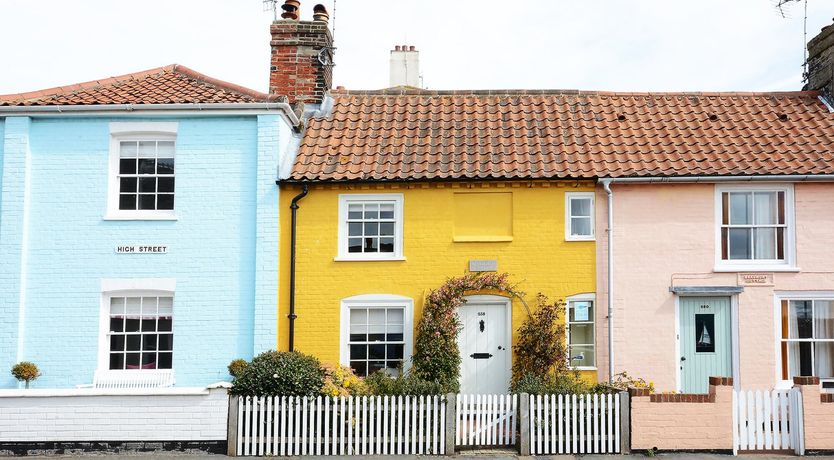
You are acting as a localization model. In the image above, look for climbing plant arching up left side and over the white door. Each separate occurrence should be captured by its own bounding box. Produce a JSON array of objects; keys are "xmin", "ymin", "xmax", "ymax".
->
[{"xmin": 412, "ymin": 273, "xmax": 524, "ymax": 392}]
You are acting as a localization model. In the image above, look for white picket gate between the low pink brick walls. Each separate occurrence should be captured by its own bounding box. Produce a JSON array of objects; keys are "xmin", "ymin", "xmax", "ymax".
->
[{"xmin": 733, "ymin": 389, "xmax": 805, "ymax": 455}]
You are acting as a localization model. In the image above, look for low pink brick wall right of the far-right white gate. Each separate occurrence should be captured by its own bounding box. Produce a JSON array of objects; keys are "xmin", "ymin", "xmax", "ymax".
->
[{"xmin": 794, "ymin": 377, "xmax": 834, "ymax": 451}]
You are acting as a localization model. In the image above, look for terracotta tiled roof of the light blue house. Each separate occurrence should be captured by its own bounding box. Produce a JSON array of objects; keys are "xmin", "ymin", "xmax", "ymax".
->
[{"xmin": 0, "ymin": 64, "xmax": 277, "ymax": 106}]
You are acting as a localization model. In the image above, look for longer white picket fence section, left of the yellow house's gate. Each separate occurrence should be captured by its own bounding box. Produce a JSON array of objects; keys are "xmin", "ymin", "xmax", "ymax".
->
[{"xmin": 235, "ymin": 396, "xmax": 446, "ymax": 456}]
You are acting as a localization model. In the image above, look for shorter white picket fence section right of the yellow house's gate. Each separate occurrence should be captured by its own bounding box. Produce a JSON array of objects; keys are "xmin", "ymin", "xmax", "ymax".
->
[{"xmin": 530, "ymin": 394, "xmax": 620, "ymax": 455}]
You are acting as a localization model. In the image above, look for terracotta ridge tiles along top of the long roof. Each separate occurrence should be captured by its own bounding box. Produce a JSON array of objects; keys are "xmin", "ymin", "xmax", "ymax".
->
[{"xmin": 330, "ymin": 86, "xmax": 820, "ymax": 97}]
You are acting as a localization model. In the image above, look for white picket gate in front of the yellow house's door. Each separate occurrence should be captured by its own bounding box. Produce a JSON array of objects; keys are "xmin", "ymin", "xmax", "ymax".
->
[{"xmin": 455, "ymin": 394, "xmax": 518, "ymax": 446}]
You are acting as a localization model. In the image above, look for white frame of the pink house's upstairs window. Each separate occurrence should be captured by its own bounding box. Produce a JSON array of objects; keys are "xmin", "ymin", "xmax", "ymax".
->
[{"xmin": 713, "ymin": 183, "xmax": 799, "ymax": 273}]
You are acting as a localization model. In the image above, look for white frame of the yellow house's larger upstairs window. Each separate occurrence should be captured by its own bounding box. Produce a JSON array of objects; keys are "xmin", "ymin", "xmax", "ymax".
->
[{"xmin": 334, "ymin": 193, "xmax": 405, "ymax": 262}]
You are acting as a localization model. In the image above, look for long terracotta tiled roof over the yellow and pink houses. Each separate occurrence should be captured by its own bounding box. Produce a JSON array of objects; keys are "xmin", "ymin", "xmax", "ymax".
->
[{"xmin": 290, "ymin": 89, "xmax": 834, "ymax": 181}]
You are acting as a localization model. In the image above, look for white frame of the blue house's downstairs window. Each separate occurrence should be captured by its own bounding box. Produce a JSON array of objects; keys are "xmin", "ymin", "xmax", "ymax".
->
[{"xmin": 96, "ymin": 278, "xmax": 177, "ymax": 377}]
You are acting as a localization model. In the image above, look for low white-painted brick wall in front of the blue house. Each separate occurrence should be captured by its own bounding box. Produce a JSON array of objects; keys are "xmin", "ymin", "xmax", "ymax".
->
[{"xmin": 0, "ymin": 388, "xmax": 229, "ymax": 442}]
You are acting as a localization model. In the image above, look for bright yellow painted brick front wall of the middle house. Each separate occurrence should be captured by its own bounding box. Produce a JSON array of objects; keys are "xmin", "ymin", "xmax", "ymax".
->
[{"xmin": 277, "ymin": 182, "xmax": 599, "ymax": 381}]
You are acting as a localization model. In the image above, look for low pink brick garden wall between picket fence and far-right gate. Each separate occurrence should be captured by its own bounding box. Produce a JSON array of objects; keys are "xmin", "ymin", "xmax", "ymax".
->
[{"xmin": 631, "ymin": 377, "xmax": 733, "ymax": 450}]
